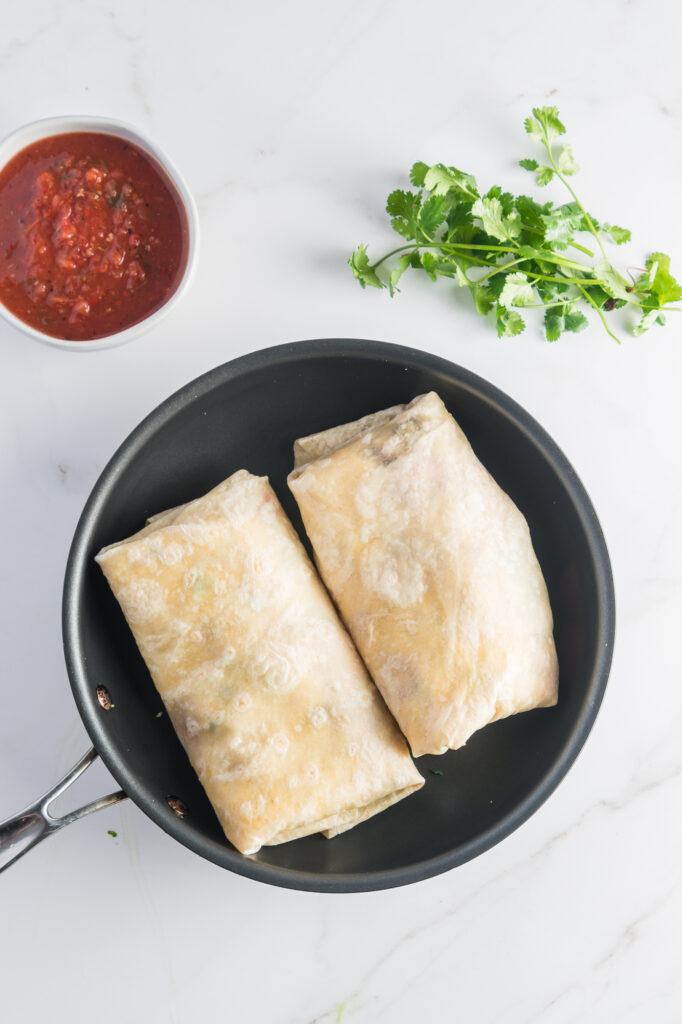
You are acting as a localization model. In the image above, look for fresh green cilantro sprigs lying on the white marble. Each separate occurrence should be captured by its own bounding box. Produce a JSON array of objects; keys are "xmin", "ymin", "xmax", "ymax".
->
[{"xmin": 348, "ymin": 106, "xmax": 682, "ymax": 341}]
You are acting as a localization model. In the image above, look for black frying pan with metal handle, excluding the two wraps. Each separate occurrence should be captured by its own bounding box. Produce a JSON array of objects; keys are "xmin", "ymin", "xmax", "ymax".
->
[{"xmin": 0, "ymin": 340, "xmax": 614, "ymax": 892}]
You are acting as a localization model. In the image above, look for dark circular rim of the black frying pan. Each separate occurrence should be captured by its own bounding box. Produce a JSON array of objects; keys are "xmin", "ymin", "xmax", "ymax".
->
[{"xmin": 62, "ymin": 338, "xmax": 615, "ymax": 893}]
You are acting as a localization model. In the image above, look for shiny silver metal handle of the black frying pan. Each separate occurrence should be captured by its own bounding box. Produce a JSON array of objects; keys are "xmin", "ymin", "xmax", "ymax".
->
[{"xmin": 0, "ymin": 748, "xmax": 126, "ymax": 871}]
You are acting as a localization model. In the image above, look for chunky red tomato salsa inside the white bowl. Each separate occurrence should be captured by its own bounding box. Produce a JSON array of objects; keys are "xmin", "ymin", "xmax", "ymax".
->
[{"xmin": 0, "ymin": 132, "xmax": 187, "ymax": 341}]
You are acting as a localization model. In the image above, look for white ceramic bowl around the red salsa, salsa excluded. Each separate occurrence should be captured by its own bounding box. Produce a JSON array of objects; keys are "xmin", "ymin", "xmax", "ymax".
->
[{"xmin": 0, "ymin": 115, "xmax": 199, "ymax": 352}]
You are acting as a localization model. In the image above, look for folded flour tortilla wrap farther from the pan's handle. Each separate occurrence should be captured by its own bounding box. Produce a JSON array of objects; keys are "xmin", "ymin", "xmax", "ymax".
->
[{"xmin": 289, "ymin": 392, "xmax": 558, "ymax": 757}]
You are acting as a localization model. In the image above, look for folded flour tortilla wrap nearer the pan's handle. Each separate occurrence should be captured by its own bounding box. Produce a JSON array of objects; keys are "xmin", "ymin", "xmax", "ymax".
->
[{"xmin": 96, "ymin": 470, "xmax": 424, "ymax": 854}]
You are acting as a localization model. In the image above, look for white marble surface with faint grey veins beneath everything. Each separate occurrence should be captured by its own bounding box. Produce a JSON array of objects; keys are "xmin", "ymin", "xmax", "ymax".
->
[{"xmin": 0, "ymin": 0, "xmax": 682, "ymax": 1024}]
